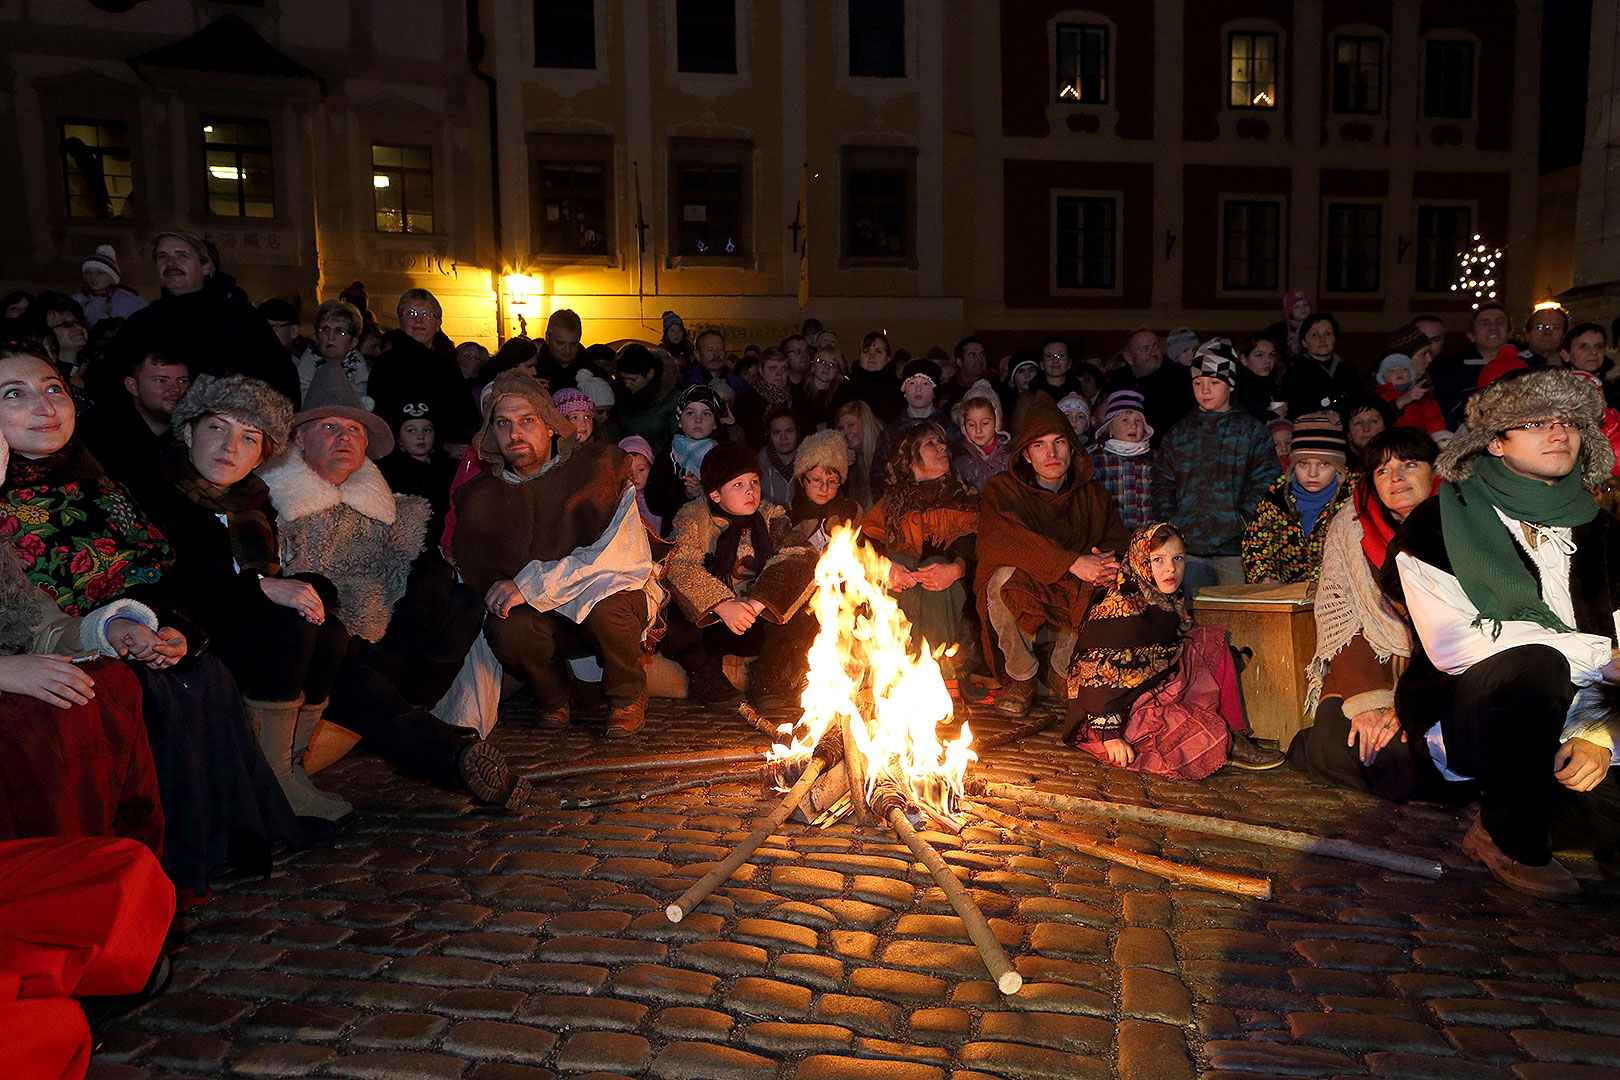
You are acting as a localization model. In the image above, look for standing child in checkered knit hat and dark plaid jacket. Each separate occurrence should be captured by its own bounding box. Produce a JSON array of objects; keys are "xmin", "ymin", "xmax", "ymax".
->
[{"xmin": 1152, "ymin": 337, "xmax": 1277, "ymax": 599}]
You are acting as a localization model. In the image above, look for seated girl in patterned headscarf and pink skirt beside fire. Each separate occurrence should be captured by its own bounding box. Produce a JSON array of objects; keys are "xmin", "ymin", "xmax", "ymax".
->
[{"xmin": 1064, "ymin": 523, "xmax": 1283, "ymax": 780}]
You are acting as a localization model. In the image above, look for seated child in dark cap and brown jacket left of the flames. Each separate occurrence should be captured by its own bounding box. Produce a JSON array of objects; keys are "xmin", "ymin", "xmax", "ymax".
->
[{"xmin": 663, "ymin": 442, "xmax": 816, "ymax": 706}]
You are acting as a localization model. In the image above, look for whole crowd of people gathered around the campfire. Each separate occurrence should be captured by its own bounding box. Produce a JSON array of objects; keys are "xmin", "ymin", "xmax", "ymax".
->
[{"xmin": 0, "ymin": 232, "xmax": 1620, "ymax": 904}]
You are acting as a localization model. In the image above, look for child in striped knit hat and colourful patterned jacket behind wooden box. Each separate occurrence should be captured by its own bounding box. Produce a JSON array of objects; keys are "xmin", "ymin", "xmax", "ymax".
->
[{"xmin": 1243, "ymin": 413, "xmax": 1356, "ymax": 583}]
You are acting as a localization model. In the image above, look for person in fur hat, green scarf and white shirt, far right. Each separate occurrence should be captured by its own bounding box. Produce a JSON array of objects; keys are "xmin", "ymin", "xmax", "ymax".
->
[{"xmin": 1383, "ymin": 369, "xmax": 1620, "ymax": 899}]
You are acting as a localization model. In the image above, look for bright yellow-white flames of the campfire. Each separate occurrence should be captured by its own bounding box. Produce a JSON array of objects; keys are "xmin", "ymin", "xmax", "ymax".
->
[{"xmin": 771, "ymin": 526, "xmax": 978, "ymax": 814}]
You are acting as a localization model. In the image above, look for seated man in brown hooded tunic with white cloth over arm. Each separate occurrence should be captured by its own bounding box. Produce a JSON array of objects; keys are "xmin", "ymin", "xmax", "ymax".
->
[{"xmin": 452, "ymin": 371, "xmax": 663, "ymax": 738}]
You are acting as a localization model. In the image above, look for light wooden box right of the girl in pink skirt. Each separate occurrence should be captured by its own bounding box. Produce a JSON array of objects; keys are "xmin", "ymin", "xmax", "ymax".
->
[{"xmin": 1192, "ymin": 585, "xmax": 1315, "ymax": 750}]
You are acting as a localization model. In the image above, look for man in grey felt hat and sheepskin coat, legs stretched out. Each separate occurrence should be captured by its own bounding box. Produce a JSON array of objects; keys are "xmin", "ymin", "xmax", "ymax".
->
[{"xmin": 259, "ymin": 364, "xmax": 528, "ymax": 810}]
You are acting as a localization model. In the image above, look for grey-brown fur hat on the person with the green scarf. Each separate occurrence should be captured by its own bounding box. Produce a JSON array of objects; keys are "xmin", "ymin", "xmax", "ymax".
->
[{"xmin": 1434, "ymin": 368, "xmax": 1615, "ymax": 487}]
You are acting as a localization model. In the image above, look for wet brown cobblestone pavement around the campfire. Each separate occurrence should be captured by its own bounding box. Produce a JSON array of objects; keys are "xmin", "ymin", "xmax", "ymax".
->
[{"xmin": 91, "ymin": 703, "xmax": 1620, "ymax": 1080}]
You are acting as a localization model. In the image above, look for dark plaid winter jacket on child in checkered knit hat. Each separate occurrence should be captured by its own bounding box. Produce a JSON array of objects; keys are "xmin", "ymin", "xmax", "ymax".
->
[{"xmin": 1153, "ymin": 406, "xmax": 1277, "ymax": 555}]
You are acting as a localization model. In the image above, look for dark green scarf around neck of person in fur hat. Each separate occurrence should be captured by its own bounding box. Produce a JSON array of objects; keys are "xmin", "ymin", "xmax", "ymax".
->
[{"xmin": 1439, "ymin": 455, "xmax": 1597, "ymax": 638}]
